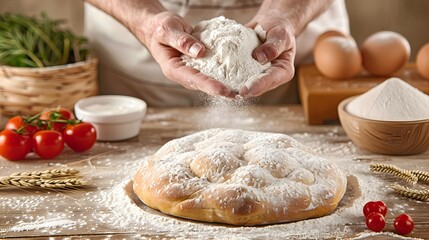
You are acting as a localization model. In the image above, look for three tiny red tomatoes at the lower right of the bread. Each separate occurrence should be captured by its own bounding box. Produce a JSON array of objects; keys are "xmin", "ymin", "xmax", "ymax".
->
[{"xmin": 363, "ymin": 201, "xmax": 414, "ymax": 235}]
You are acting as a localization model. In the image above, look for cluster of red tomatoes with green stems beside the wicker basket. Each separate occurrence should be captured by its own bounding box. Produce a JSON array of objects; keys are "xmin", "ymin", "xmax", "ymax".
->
[{"xmin": 0, "ymin": 107, "xmax": 97, "ymax": 160}]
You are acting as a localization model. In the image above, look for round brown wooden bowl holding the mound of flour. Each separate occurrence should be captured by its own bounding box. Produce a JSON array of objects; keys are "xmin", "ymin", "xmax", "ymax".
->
[{"xmin": 338, "ymin": 97, "xmax": 429, "ymax": 155}]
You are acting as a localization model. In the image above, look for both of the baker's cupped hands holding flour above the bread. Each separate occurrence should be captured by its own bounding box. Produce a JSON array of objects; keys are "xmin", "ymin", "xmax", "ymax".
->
[{"xmin": 137, "ymin": 12, "xmax": 296, "ymax": 98}]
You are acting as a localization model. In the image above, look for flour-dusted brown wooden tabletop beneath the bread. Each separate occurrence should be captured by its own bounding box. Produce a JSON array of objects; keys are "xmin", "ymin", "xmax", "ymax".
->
[{"xmin": 0, "ymin": 105, "xmax": 429, "ymax": 239}]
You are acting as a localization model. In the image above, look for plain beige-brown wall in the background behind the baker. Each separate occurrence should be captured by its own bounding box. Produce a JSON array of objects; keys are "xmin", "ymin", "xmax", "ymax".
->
[{"xmin": 0, "ymin": 0, "xmax": 429, "ymax": 60}]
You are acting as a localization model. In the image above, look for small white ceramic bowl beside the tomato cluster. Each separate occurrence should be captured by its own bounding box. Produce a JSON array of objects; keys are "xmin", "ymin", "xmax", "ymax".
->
[{"xmin": 74, "ymin": 95, "xmax": 147, "ymax": 141}]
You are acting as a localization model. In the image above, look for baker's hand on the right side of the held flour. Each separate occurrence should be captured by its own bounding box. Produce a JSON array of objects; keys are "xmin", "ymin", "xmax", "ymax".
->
[{"xmin": 239, "ymin": 12, "xmax": 296, "ymax": 97}]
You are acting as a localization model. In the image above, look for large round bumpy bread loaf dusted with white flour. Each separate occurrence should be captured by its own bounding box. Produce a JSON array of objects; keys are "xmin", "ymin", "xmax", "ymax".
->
[{"xmin": 133, "ymin": 129, "xmax": 346, "ymax": 226}]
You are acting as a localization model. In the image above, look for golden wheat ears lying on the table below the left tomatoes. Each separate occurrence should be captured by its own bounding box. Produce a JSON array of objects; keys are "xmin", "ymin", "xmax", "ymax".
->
[{"xmin": 0, "ymin": 168, "xmax": 89, "ymax": 189}]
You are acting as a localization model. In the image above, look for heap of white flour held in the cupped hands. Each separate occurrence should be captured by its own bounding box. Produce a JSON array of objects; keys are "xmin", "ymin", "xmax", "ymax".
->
[{"xmin": 182, "ymin": 16, "xmax": 270, "ymax": 90}]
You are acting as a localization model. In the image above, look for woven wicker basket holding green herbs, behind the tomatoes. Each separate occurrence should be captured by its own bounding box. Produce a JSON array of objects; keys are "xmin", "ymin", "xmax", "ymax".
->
[{"xmin": 0, "ymin": 58, "xmax": 98, "ymax": 115}]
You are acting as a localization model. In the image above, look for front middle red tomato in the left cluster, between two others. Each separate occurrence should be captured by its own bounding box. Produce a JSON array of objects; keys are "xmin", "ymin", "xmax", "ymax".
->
[{"xmin": 33, "ymin": 130, "xmax": 64, "ymax": 159}]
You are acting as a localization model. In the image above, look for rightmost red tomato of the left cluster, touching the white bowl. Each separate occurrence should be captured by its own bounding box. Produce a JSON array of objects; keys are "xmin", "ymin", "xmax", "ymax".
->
[{"xmin": 64, "ymin": 122, "xmax": 97, "ymax": 152}]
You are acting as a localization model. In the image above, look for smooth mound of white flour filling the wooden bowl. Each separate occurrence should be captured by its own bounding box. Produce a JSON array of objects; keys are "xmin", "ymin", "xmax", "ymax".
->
[{"xmin": 346, "ymin": 78, "xmax": 429, "ymax": 121}]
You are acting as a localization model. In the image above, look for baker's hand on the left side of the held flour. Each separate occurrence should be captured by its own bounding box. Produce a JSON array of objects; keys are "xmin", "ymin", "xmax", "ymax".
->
[{"xmin": 137, "ymin": 12, "xmax": 236, "ymax": 98}]
